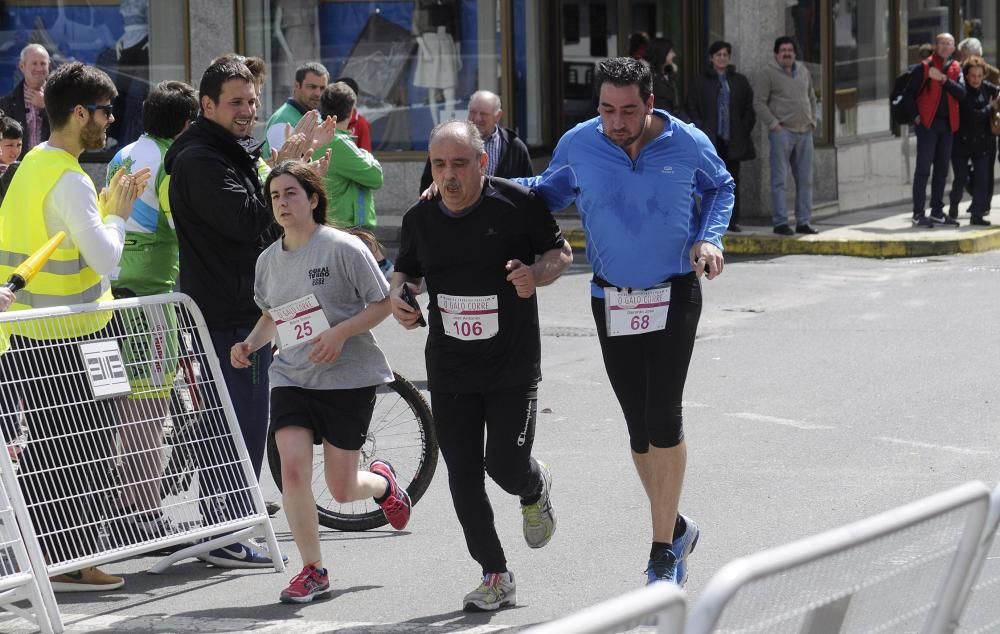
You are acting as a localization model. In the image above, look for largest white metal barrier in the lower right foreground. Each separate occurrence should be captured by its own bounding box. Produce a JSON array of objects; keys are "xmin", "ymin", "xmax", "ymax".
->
[{"xmin": 685, "ymin": 482, "xmax": 989, "ymax": 634}]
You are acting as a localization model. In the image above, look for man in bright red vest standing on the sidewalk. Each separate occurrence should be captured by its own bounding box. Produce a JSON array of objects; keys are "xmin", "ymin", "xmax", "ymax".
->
[{"xmin": 903, "ymin": 33, "xmax": 965, "ymax": 229}]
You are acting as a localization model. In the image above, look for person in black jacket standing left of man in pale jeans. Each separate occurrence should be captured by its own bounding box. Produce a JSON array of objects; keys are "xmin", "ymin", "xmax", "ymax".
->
[{"xmin": 687, "ymin": 41, "xmax": 757, "ymax": 232}]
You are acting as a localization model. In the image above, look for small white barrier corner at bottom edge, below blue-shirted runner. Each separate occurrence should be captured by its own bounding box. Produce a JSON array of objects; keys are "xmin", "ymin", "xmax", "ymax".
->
[{"xmin": 524, "ymin": 583, "xmax": 686, "ymax": 634}]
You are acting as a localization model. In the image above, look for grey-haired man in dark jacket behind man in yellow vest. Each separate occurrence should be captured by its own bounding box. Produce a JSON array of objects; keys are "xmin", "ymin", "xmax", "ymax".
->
[{"xmin": 0, "ymin": 44, "xmax": 49, "ymax": 160}]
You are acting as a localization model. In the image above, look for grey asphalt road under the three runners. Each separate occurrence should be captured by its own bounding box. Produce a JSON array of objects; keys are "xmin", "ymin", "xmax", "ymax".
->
[{"xmin": 0, "ymin": 252, "xmax": 1000, "ymax": 634}]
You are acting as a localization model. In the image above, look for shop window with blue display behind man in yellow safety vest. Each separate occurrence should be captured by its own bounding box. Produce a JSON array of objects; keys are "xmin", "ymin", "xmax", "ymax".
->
[{"xmin": 0, "ymin": 0, "xmax": 187, "ymax": 160}]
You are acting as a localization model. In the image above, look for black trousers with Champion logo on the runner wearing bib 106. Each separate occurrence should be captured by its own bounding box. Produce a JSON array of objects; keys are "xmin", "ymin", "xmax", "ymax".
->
[{"xmin": 431, "ymin": 382, "xmax": 542, "ymax": 575}]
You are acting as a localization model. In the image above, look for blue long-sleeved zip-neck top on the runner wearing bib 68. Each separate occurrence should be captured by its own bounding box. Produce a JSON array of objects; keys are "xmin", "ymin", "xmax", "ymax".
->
[{"xmin": 512, "ymin": 110, "xmax": 735, "ymax": 297}]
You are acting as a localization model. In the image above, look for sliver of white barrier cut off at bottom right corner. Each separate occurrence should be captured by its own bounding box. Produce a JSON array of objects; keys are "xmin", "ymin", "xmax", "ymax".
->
[{"xmin": 954, "ymin": 486, "xmax": 1000, "ymax": 634}]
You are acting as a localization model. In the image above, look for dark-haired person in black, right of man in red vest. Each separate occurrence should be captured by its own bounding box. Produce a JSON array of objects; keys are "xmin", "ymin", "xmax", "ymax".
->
[{"xmin": 948, "ymin": 55, "xmax": 1000, "ymax": 226}]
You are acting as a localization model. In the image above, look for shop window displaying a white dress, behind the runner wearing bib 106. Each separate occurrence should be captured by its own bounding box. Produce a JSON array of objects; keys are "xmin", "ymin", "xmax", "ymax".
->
[{"xmin": 244, "ymin": 0, "xmax": 501, "ymax": 152}]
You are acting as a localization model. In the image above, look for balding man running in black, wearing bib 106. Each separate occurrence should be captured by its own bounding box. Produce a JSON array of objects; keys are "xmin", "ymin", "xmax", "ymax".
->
[{"xmin": 389, "ymin": 121, "xmax": 573, "ymax": 611}]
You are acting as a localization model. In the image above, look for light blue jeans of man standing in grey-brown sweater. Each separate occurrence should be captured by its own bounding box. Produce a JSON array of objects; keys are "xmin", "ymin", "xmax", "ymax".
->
[{"xmin": 767, "ymin": 128, "xmax": 813, "ymax": 227}]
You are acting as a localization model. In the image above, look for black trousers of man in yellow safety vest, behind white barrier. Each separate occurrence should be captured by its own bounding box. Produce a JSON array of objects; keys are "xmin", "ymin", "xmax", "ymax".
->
[{"xmin": 0, "ymin": 327, "xmax": 118, "ymax": 564}]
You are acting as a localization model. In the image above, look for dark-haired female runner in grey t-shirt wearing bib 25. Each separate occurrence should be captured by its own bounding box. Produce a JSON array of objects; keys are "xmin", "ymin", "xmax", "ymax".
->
[{"xmin": 230, "ymin": 161, "xmax": 411, "ymax": 603}]
